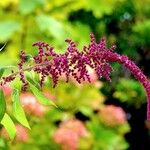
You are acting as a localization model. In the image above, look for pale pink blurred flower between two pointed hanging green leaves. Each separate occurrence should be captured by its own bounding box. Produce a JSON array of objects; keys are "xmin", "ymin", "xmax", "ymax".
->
[{"xmin": 20, "ymin": 93, "xmax": 46, "ymax": 117}]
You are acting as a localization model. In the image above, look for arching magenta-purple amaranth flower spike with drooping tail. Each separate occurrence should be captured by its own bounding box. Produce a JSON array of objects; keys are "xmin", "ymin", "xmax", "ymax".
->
[{"xmin": 1, "ymin": 34, "xmax": 150, "ymax": 120}]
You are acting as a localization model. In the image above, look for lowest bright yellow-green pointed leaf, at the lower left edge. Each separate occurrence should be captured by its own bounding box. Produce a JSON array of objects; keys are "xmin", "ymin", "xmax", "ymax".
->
[{"xmin": 1, "ymin": 113, "xmax": 16, "ymax": 140}]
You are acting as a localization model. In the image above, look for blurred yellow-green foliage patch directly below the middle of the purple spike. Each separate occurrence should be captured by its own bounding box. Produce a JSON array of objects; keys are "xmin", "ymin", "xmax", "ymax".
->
[{"xmin": 51, "ymin": 81, "xmax": 104, "ymax": 113}]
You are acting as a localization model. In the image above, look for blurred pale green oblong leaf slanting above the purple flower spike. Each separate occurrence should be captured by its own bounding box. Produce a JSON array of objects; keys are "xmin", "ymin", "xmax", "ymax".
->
[{"xmin": 36, "ymin": 15, "xmax": 65, "ymax": 41}]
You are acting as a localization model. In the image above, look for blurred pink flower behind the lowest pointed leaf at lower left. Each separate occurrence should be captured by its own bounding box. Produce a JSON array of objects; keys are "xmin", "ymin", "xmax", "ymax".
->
[{"xmin": 1, "ymin": 124, "xmax": 29, "ymax": 142}]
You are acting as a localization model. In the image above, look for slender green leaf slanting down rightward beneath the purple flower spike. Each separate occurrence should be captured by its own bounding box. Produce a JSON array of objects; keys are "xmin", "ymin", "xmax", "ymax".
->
[{"xmin": 29, "ymin": 82, "xmax": 57, "ymax": 107}]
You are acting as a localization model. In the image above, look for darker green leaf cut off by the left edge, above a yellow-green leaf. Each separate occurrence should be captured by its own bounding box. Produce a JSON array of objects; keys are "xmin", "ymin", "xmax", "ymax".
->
[{"xmin": 0, "ymin": 89, "xmax": 6, "ymax": 121}]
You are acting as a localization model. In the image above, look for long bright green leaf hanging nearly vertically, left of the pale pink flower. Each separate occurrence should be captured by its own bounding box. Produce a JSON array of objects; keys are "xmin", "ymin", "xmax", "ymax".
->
[{"xmin": 12, "ymin": 89, "xmax": 30, "ymax": 129}]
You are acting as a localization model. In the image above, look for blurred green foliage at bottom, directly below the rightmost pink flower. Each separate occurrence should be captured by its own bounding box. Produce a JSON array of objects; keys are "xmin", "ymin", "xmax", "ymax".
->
[{"xmin": 87, "ymin": 118, "xmax": 129, "ymax": 150}]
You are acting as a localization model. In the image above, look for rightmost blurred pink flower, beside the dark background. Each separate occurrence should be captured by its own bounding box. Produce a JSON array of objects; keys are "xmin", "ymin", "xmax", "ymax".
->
[{"xmin": 99, "ymin": 105, "xmax": 126, "ymax": 127}]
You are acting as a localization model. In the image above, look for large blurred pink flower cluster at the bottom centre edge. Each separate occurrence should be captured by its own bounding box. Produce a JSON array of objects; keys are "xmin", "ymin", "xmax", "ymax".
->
[{"xmin": 54, "ymin": 119, "xmax": 88, "ymax": 150}]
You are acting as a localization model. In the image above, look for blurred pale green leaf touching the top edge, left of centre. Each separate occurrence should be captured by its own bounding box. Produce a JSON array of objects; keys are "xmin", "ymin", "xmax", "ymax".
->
[{"xmin": 19, "ymin": 0, "xmax": 45, "ymax": 15}]
